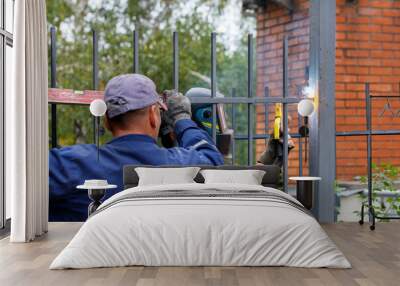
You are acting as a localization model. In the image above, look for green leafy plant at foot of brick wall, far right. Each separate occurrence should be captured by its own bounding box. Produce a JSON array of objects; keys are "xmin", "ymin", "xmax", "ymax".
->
[{"xmin": 357, "ymin": 163, "xmax": 400, "ymax": 219}]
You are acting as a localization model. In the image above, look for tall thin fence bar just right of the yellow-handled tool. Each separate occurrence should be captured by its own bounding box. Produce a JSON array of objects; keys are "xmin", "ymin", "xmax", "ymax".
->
[{"xmin": 282, "ymin": 35, "xmax": 289, "ymax": 193}]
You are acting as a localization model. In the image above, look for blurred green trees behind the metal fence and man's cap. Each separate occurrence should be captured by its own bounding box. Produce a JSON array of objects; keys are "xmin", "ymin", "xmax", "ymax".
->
[{"xmin": 47, "ymin": 0, "xmax": 255, "ymax": 164}]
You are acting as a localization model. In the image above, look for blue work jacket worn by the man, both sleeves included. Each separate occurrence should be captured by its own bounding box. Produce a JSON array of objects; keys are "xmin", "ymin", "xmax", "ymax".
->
[{"xmin": 49, "ymin": 119, "xmax": 223, "ymax": 221}]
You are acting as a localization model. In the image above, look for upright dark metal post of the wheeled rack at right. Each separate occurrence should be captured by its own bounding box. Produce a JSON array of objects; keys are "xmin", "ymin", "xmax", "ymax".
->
[{"xmin": 365, "ymin": 83, "xmax": 372, "ymax": 222}]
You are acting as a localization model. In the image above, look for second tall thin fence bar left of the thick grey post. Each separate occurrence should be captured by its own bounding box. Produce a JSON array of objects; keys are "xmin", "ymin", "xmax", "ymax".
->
[{"xmin": 247, "ymin": 34, "xmax": 254, "ymax": 166}]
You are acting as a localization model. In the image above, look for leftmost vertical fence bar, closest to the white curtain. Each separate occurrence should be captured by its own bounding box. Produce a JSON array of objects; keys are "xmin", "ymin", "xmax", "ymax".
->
[{"xmin": 50, "ymin": 27, "xmax": 58, "ymax": 148}]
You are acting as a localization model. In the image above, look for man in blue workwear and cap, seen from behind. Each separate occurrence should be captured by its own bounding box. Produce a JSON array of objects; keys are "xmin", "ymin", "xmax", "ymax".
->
[{"xmin": 49, "ymin": 74, "xmax": 223, "ymax": 221}]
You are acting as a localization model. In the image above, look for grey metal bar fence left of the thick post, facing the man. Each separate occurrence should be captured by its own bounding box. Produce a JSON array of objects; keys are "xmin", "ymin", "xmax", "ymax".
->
[{"xmin": 49, "ymin": 27, "xmax": 303, "ymax": 192}]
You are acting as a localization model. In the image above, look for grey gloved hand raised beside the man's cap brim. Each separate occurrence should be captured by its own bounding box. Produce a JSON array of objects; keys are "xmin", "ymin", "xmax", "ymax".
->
[{"xmin": 163, "ymin": 90, "xmax": 192, "ymax": 126}]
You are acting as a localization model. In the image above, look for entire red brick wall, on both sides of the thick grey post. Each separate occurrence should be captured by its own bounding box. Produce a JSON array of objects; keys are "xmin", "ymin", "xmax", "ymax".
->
[{"xmin": 256, "ymin": 0, "xmax": 400, "ymax": 180}]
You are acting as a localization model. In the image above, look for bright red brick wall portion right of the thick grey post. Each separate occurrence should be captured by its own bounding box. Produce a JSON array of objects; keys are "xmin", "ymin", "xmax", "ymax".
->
[{"xmin": 336, "ymin": 0, "xmax": 400, "ymax": 179}]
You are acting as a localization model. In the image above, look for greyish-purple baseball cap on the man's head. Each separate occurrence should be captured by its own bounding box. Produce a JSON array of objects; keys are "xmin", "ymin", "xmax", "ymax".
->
[{"xmin": 104, "ymin": 74, "xmax": 166, "ymax": 118}]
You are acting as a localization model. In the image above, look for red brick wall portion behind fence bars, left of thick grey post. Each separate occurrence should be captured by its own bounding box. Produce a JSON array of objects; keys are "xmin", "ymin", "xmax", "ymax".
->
[{"xmin": 256, "ymin": 0, "xmax": 309, "ymax": 175}]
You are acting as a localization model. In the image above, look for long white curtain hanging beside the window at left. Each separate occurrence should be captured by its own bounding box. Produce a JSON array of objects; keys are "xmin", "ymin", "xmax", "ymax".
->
[{"xmin": 5, "ymin": 0, "xmax": 48, "ymax": 242}]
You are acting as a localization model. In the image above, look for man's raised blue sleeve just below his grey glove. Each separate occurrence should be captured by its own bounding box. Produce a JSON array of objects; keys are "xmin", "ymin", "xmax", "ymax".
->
[{"xmin": 172, "ymin": 119, "xmax": 224, "ymax": 165}]
